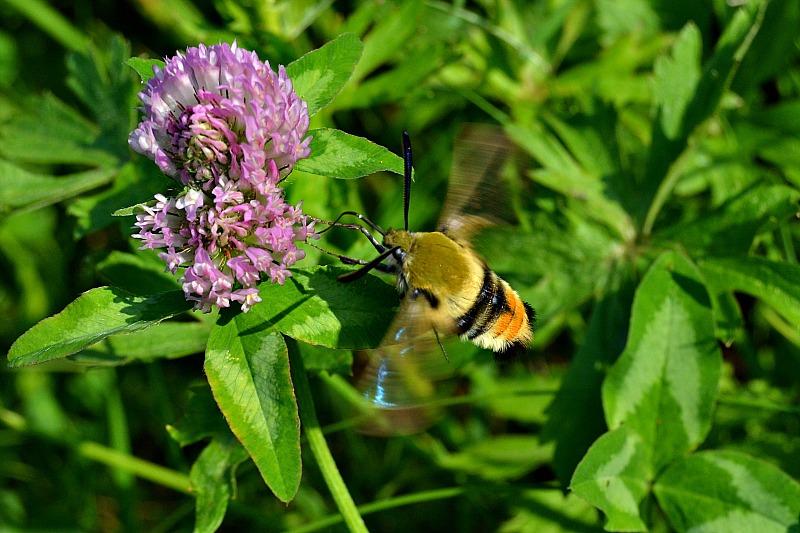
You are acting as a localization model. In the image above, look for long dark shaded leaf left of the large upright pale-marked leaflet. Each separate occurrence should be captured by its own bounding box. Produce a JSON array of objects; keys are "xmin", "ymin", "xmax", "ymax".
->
[{"xmin": 542, "ymin": 268, "xmax": 634, "ymax": 486}]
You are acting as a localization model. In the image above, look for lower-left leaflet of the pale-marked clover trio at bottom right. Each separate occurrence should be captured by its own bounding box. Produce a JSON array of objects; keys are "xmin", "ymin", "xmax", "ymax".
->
[{"xmin": 570, "ymin": 426, "xmax": 653, "ymax": 531}]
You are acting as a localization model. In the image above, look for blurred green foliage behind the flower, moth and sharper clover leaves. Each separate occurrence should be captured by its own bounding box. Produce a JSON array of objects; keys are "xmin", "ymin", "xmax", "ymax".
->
[{"xmin": 0, "ymin": 0, "xmax": 800, "ymax": 532}]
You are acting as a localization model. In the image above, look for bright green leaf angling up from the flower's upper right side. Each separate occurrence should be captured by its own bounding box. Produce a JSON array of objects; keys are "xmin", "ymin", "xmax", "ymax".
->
[{"xmin": 286, "ymin": 33, "xmax": 364, "ymax": 116}]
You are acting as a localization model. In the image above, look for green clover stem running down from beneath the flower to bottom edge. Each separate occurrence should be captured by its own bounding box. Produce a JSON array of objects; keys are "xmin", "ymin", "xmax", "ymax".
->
[{"xmin": 286, "ymin": 338, "xmax": 368, "ymax": 533}]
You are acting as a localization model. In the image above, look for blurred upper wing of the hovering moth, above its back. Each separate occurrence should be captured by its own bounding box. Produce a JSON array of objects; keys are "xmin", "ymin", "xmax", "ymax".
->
[{"xmin": 437, "ymin": 124, "xmax": 516, "ymax": 240}]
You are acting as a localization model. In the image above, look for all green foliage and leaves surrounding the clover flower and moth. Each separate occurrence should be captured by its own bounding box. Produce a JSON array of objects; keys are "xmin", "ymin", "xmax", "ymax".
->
[{"xmin": 0, "ymin": 0, "xmax": 800, "ymax": 533}]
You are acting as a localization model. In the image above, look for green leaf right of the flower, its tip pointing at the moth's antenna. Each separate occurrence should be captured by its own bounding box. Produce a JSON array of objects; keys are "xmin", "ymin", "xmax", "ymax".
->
[{"xmin": 295, "ymin": 128, "xmax": 403, "ymax": 179}]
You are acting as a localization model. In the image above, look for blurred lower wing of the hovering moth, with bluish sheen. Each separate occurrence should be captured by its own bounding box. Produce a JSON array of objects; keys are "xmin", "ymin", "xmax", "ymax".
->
[{"xmin": 356, "ymin": 299, "xmax": 454, "ymax": 436}]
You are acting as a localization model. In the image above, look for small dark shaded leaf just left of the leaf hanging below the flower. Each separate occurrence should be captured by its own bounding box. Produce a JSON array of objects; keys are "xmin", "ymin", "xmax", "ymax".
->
[{"xmin": 167, "ymin": 385, "xmax": 233, "ymax": 447}]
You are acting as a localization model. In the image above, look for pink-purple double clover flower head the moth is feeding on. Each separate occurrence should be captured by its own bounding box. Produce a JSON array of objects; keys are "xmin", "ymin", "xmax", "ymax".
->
[{"xmin": 129, "ymin": 43, "xmax": 317, "ymax": 312}]
